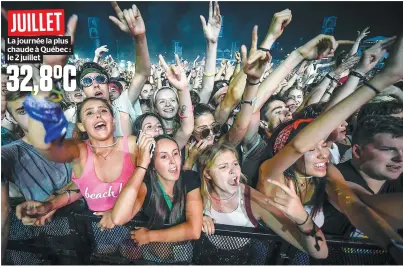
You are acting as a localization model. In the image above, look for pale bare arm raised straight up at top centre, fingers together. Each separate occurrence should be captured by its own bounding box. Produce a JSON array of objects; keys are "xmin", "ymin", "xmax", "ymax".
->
[{"xmin": 199, "ymin": 1, "xmax": 221, "ymax": 104}]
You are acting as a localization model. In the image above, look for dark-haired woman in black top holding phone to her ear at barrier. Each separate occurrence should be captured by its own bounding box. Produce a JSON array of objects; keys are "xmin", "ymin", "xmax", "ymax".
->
[{"xmin": 112, "ymin": 134, "xmax": 203, "ymax": 261}]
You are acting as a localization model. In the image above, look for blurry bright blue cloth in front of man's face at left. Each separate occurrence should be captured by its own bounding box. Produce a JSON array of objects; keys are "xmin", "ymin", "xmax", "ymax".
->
[{"xmin": 23, "ymin": 94, "xmax": 68, "ymax": 145}]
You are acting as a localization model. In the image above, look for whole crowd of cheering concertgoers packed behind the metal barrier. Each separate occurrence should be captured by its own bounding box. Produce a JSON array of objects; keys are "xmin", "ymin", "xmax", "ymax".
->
[{"xmin": 1, "ymin": 2, "xmax": 403, "ymax": 262}]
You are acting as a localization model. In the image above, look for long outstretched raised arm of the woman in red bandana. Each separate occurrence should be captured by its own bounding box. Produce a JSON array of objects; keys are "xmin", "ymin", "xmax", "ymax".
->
[{"xmin": 259, "ymin": 35, "xmax": 403, "ymax": 181}]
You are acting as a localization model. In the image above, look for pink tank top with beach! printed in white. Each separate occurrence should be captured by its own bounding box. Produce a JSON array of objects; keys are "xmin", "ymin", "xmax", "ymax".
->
[{"xmin": 72, "ymin": 136, "xmax": 134, "ymax": 212}]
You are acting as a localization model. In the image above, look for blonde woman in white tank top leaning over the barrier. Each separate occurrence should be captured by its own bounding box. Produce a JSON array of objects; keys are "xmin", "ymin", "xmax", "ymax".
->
[{"xmin": 198, "ymin": 144, "xmax": 328, "ymax": 258}]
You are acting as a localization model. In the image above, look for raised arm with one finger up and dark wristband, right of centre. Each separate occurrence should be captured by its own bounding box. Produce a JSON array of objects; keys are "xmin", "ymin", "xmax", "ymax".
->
[{"xmin": 221, "ymin": 26, "xmax": 271, "ymax": 146}]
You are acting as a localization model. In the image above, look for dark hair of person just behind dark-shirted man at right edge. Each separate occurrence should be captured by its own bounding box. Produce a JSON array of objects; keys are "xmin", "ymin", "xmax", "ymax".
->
[{"xmin": 357, "ymin": 101, "xmax": 403, "ymax": 121}]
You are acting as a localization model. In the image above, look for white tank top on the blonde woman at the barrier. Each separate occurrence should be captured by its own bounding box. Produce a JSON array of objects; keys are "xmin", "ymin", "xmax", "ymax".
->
[{"xmin": 205, "ymin": 184, "xmax": 255, "ymax": 227}]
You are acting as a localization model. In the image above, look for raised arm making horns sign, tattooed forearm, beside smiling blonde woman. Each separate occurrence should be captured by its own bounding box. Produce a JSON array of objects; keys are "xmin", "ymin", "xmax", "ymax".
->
[{"xmin": 159, "ymin": 55, "xmax": 194, "ymax": 150}]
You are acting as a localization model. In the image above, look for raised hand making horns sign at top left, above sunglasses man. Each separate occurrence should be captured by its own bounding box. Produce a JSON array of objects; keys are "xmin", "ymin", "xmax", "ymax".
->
[{"xmin": 109, "ymin": 1, "xmax": 146, "ymax": 38}]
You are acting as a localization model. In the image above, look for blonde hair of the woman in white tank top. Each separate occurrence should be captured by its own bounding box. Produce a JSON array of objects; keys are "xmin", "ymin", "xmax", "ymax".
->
[{"xmin": 197, "ymin": 143, "xmax": 248, "ymax": 211}]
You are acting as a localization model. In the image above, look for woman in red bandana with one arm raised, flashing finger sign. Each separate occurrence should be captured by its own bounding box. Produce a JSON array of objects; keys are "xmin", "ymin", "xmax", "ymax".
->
[{"xmin": 257, "ymin": 36, "xmax": 403, "ymax": 260}]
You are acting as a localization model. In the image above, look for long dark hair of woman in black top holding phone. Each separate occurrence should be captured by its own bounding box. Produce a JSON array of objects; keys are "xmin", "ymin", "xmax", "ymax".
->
[{"xmin": 146, "ymin": 135, "xmax": 186, "ymax": 229}]
